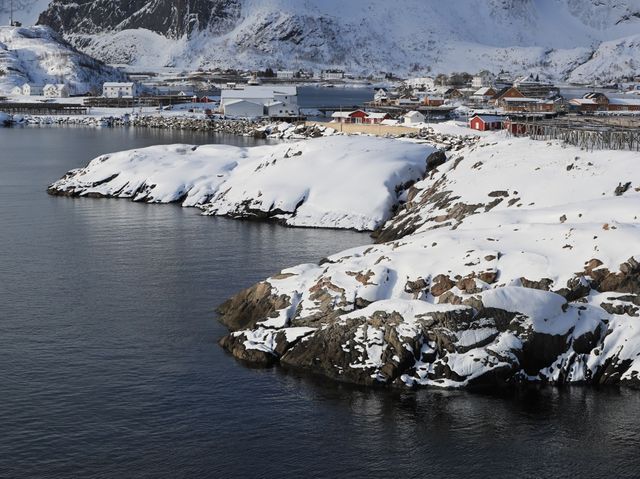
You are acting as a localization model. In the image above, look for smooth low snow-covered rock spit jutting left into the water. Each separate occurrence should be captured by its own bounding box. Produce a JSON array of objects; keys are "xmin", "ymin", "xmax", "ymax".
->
[{"xmin": 49, "ymin": 136, "xmax": 435, "ymax": 230}]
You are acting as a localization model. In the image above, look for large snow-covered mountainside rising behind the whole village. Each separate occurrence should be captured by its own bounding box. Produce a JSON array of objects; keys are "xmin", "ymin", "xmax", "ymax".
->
[{"xmin": 33, "ymin": 0, "xmax": 640, "ymax": 79}]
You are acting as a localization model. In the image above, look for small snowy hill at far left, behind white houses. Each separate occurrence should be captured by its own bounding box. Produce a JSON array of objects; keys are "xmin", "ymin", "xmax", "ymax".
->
[{"xmin": 0, "ymin": 27, "xmax": 122, "ymax": 94}]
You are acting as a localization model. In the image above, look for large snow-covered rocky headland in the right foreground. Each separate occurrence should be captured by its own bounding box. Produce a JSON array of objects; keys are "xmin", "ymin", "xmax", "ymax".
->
[{"xmin": 219, "ymin": 135, "xmax": 640, "ymax": 387}]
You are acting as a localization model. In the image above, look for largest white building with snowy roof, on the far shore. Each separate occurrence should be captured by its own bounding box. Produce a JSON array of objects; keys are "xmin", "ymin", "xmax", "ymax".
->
[{"xmin": 220, "ymin": 86, "xmax": 300, "ymax": 118}]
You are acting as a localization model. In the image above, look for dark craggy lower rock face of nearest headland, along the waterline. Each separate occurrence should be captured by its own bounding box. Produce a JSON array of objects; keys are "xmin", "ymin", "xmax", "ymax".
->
[{"xmin": 219, "ymin": 258, "xmax": 640, "ymax": 388}]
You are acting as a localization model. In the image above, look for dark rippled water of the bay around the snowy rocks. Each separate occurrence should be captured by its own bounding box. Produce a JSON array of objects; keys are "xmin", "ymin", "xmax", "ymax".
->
[{"xmin": 0, "ymin": 128, "xmax": 640, "ymax": 478}]
